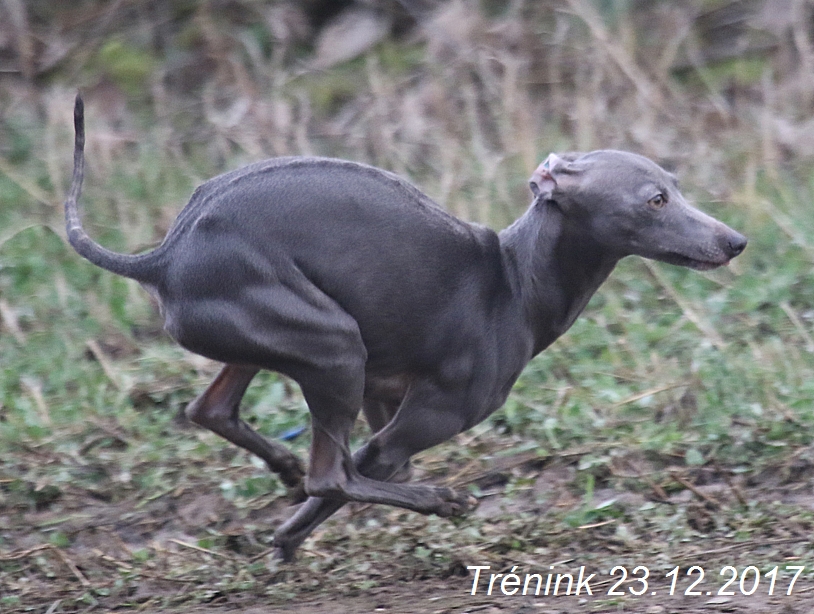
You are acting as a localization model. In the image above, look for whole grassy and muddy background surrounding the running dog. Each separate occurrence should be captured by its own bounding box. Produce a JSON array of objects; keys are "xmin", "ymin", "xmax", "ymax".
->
[{"xmin": 0, "ymin": 0, "xmax": 814, "ymax": 614}]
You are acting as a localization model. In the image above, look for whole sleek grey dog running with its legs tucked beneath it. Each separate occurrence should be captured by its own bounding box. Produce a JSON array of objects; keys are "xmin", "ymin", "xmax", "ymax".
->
[{"xmin": 65, "ymin": 96, "xmax": 746, "ymax": 560}]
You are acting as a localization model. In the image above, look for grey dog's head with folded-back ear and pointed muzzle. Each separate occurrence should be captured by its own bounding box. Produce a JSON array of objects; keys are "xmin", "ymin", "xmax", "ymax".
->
[{"xmin": 530, "ymin": 150, "xmax": 746, "ymax": 270}]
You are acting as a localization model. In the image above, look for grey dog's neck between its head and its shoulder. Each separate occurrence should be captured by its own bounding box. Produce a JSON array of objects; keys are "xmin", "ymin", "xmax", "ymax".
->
[{"xmin": 500, "ymin": 202, "xmax": 620, "ymax": 355}]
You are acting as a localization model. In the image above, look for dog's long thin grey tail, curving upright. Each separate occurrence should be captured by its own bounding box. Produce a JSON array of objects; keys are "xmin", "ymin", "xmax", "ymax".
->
[{"xmin": 65, "ymin": 94, "xmax": 158, "ymax": 283}]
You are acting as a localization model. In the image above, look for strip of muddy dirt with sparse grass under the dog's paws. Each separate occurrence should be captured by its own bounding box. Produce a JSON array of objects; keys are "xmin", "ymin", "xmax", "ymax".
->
[{"xmin": 6, "ymin": 450, "xmax": 814, "ymax": 614}]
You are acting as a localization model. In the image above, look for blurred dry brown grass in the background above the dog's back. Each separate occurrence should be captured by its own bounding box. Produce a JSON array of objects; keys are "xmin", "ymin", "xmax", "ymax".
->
[{"xmin": 0, "ymin": 0, "xmax": 814, "ymax": 233}]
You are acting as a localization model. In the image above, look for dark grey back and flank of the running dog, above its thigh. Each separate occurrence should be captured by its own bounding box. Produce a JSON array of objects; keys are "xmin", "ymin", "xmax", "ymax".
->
[{"xmin": 162, "ymin": 158, "xmax": 509, "ymax": 372}]
